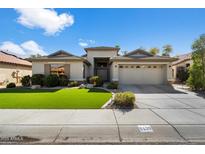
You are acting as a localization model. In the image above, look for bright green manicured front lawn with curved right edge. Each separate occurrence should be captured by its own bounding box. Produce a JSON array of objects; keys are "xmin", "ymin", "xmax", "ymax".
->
[{"xmin": 0, "ymin": 88, "xmax": 112, "ymax": 109}]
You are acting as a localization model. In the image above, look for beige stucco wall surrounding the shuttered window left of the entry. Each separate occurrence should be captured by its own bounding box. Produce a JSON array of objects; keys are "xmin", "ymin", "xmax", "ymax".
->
[{"xmin": 32, "ymin": 61, "xmax": 84, "ymax": 81}]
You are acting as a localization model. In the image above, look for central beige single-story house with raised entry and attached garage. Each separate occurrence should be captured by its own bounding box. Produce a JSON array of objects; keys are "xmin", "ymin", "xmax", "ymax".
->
[{"xmin": 31, "ymin": 47, "xmax": 177, "ymax": 84}]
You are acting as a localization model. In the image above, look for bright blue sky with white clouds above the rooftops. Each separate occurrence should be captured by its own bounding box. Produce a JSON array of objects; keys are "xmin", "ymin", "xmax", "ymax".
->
[{"xmin": 0, "ymin": 9, "xmax": 205, "ymax": 56}]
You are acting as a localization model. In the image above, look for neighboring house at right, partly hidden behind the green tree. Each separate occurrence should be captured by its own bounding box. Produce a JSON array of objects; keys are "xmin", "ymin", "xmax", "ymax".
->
[{"xmin": 172, "ymin": 53, "xmax": 193, "ymax": 81}]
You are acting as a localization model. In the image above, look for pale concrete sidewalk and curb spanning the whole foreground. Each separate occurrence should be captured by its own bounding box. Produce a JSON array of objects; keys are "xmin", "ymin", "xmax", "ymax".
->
[{"xmin": 0, "ymin": 108, "xmax": 205, "ymax": 144}]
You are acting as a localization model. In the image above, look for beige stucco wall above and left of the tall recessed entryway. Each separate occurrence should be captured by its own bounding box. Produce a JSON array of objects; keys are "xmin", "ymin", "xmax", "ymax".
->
[{"xmin": 87, "ymin": 50, "xmax": 117, "ymax": 76}]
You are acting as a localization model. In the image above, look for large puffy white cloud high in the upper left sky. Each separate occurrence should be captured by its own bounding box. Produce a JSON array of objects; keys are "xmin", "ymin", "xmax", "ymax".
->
[{"xmin": 16, "ymin": 8, "xmax": 74, "ymax": 35}]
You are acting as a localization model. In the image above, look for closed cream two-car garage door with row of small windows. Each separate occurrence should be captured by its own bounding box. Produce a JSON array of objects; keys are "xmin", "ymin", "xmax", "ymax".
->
[{"xmin": 119, "ymin": 65, "xmax": 165, "ymax": 84}]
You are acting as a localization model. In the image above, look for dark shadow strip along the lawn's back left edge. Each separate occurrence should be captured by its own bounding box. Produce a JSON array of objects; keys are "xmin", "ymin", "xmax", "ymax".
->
[{"xmin": 0, "ymin": 88, "xmax": 61, "ymax": 94}]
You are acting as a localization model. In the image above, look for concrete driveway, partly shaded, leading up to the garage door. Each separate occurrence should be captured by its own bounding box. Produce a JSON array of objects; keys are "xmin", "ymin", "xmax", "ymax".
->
[{"xmin": 120, "ymin": 85, "xmax": 205, "ymax": 109}]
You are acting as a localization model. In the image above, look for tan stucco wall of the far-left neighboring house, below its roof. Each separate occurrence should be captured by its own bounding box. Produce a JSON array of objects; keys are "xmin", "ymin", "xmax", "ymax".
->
[{"xmin": 0, "ymin": 63, "xmax": 32, "ymax": 83}]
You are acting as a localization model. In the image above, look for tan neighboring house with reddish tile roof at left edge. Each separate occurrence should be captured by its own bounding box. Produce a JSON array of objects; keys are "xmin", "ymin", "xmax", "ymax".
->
[{"xmin": 0, "ymin": 51, "xmax": 32, "ymax": 85}]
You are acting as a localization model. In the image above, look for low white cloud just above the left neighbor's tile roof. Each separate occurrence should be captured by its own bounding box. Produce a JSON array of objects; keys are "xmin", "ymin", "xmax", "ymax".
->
[{"xmin": 0, "ymin": 40, "xmax": 47, "ymax": 58}]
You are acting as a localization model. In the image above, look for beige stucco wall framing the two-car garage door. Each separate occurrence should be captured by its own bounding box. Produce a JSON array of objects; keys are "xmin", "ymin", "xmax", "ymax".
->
[{"xmin": 111, "ymin": 62, "xmax": 173, "ymax": 83}]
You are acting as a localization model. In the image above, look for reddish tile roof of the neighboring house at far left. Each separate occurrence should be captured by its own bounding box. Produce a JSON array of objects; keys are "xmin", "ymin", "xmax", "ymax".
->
[{"xmin": 0, "ymin": 51, "xmax": 31, "ymax": 66}]
